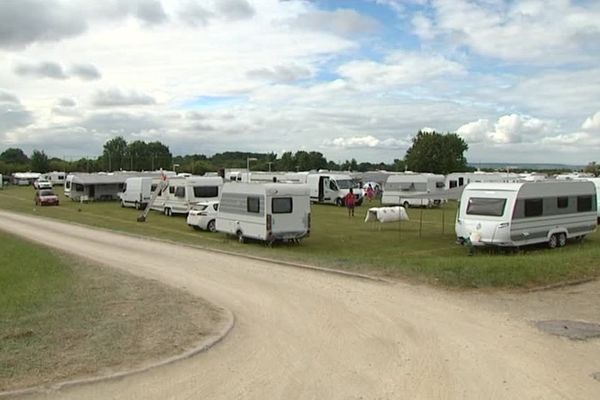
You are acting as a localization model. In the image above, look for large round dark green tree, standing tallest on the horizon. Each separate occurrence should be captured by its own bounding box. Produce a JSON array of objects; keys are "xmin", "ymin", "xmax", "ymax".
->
[{"xmin": 404, "ymin": 131, "xmax": 469, "ymax": 175}]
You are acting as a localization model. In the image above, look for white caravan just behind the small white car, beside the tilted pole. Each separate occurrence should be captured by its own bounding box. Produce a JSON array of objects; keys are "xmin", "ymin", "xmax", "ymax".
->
[{"xmin": 151, "ymin": 176, "xmax": 223, "ymax": 215}]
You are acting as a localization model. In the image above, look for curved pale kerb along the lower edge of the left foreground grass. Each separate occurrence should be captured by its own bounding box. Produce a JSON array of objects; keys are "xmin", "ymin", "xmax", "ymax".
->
[{"xmin": 0, "ymin": 309, "xmax": 235, "ymax": 399}]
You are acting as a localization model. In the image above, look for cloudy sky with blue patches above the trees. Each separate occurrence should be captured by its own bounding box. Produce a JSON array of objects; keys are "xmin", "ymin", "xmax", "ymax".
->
[{"xmin": 0, "ymin": 0, "xmax": 600, "ymax": 164}]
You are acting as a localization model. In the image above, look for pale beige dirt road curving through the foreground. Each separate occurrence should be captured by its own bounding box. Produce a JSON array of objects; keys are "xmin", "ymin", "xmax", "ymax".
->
[{"xmin": 0, "ymin": 212, "xmax": 600, "ymax": 400}]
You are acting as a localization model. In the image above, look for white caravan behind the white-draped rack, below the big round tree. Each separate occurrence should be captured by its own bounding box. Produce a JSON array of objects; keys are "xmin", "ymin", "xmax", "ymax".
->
[{"xmin": 381, "ymin": 173, "xmax": 446, "ymax": 208}]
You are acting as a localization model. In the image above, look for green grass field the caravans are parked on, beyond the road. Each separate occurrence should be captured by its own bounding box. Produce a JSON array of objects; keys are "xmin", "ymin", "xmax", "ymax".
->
[{"xmin": 0, "ymin": 187, "xmax": 600, "ymax": 287}]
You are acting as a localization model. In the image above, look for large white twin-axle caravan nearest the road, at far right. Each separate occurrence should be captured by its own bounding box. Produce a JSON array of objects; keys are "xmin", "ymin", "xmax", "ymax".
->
[{"xmin": 455, "ymin": 181, "xmax": 597, "ymax": 248}]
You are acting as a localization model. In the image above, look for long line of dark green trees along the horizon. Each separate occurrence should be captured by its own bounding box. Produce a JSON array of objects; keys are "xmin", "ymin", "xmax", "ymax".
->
[{"xmin": 5, "ymin": 131, "xmax": 600, "ymax": 175}]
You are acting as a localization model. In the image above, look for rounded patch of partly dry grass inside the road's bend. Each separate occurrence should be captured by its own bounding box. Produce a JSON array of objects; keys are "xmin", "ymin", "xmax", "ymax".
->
[{"xmin": 0, "ymin": 231, "xmax": 220, "ymax": 392}]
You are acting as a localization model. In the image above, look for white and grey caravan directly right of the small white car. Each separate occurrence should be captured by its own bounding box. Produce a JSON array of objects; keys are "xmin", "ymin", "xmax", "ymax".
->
[{"xmin": 216, "ymin": 182, "xmax": 310, "ymax": 243}]
